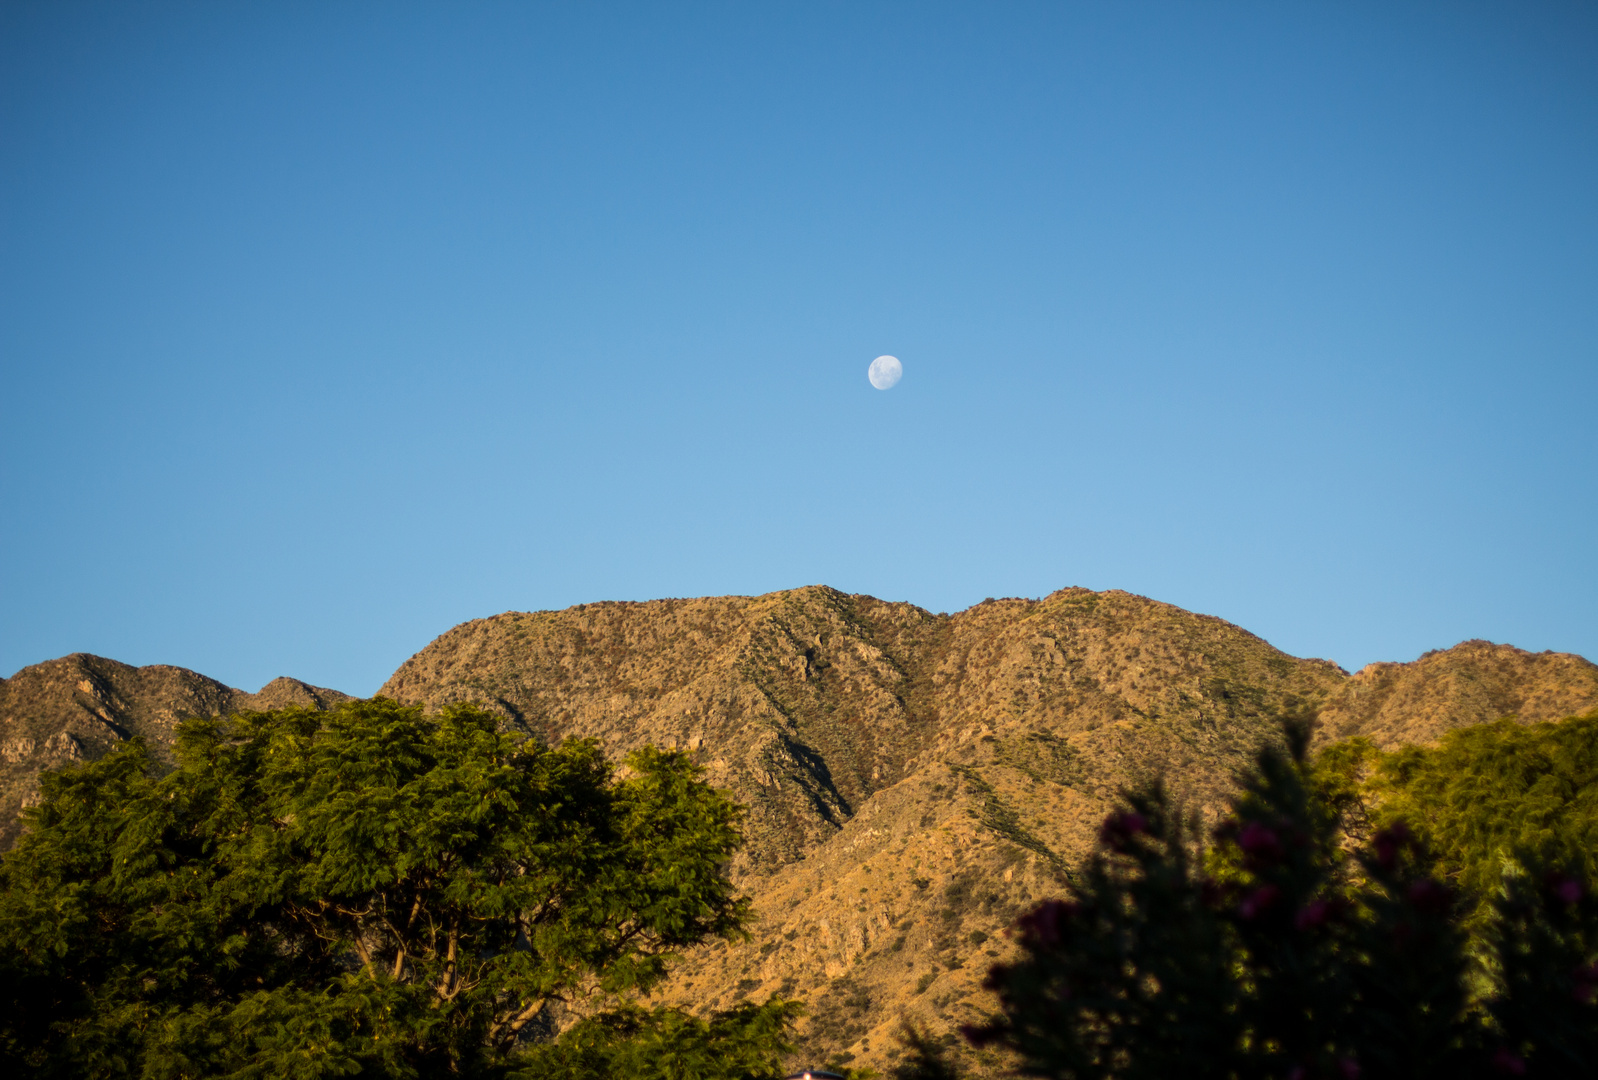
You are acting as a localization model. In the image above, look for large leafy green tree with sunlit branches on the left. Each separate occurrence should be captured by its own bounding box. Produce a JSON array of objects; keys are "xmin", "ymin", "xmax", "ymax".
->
[{"xmin": 0, "ymin": 700, "xmax": 794, "ymax": 1080}]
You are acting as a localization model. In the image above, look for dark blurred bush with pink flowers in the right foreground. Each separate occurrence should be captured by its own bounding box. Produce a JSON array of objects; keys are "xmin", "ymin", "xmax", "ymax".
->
[{"xmin": 946, "ymin": 724, "xmax": 1598, "ymax": 1080}]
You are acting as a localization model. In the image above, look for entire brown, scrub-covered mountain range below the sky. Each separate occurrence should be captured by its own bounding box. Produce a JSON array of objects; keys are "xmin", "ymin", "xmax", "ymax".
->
[{"xmin": 0, "ymin": 586, "xmax": 1598, "ymax": 1067}]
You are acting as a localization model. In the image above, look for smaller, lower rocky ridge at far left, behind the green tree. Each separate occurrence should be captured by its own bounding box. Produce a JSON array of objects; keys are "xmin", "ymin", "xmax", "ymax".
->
[{"xmin": 0, "ymin": 652, "xmax": 348, "ymax": 850}]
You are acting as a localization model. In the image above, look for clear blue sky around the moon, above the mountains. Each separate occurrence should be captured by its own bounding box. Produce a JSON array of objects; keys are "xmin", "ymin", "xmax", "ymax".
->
[{"xmin": 0, "ymin": 3, "xmax": 1598, "ymax": 693}]
